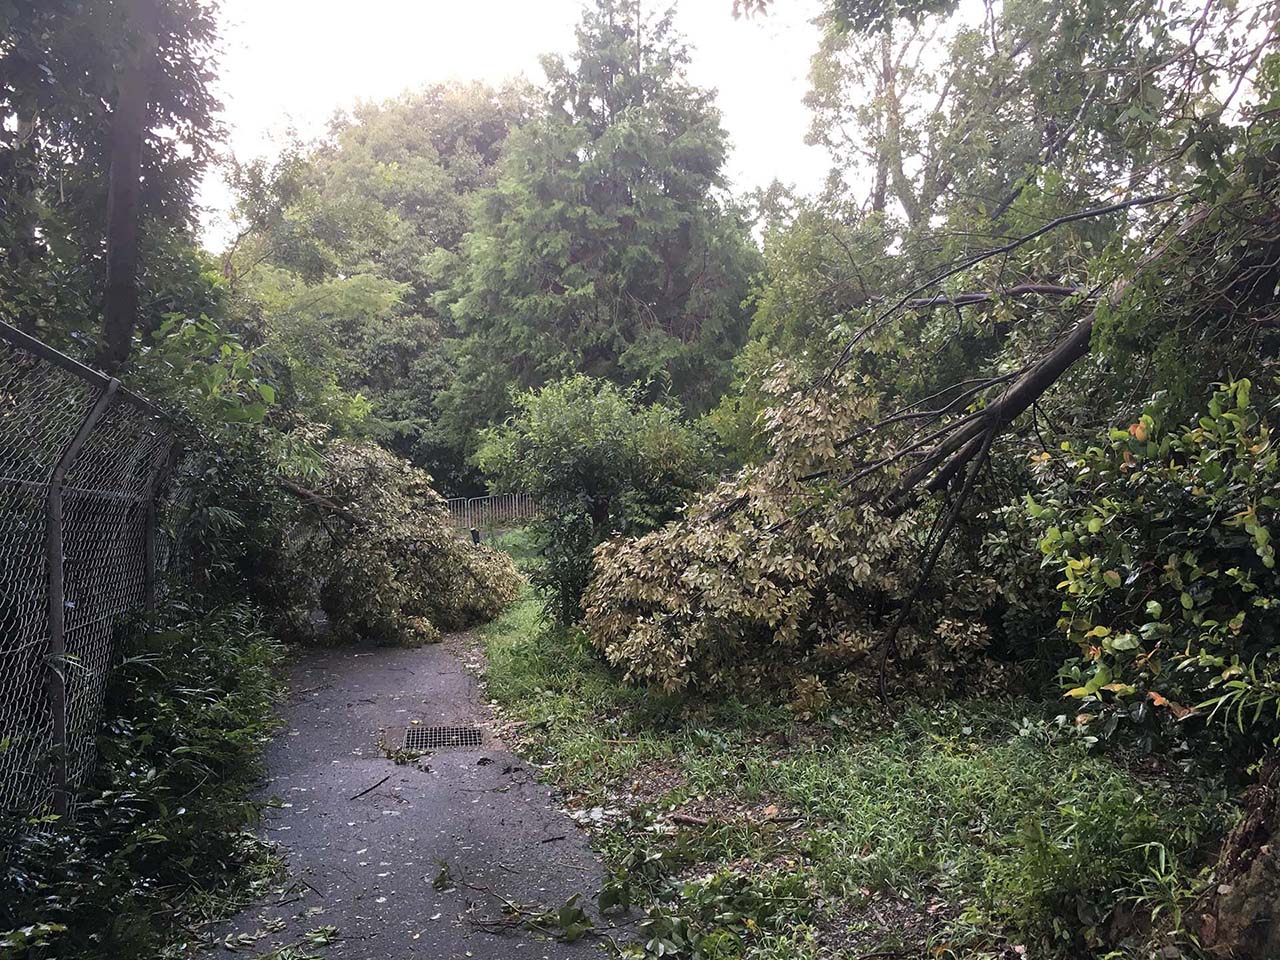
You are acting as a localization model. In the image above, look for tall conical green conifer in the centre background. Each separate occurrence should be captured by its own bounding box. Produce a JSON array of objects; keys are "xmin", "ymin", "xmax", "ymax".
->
[{"xmin": 443, "ymin": 0, "xmax": 758, "ymax": 455}]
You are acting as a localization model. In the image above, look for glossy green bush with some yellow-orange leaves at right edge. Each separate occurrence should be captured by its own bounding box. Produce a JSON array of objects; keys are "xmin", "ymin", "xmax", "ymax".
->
[{"xmin": 1028, "ymin": 380, "xmax": 1280, "ymax": 750}]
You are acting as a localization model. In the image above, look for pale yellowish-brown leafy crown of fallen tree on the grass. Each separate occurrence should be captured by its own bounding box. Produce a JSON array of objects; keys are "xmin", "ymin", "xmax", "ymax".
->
[{"xmin": 584, "ymin": 367, "xmax": 996, "ymax": 700}]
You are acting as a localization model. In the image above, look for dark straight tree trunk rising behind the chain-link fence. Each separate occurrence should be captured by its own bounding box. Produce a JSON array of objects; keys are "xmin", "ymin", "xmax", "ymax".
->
[{"xmin": 97, "ymin": 0, "xmax": 159, "ymax": 372}]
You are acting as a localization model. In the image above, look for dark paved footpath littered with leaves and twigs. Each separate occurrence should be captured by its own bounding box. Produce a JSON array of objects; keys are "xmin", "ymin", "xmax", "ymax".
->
[{"xmin": 218, "ymin": 636, "xmax": 602, "ymax": 960}]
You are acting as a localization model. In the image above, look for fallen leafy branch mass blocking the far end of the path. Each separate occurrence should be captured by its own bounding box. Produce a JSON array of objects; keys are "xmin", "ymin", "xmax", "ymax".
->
[{"xmin": 278, "ymin": 442, "xmax": 520, "ymax": 644}]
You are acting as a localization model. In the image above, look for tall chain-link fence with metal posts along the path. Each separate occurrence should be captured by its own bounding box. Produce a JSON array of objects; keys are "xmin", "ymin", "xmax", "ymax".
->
[{"xmin": 0, "ymin": 324, "xmax": 177, "ymax": 812}]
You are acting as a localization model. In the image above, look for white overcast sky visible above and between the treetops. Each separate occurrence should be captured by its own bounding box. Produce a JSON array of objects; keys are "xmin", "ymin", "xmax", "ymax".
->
[{"xmin": 201, "ymin": 0, "xmax": 828, "ymax": 247}]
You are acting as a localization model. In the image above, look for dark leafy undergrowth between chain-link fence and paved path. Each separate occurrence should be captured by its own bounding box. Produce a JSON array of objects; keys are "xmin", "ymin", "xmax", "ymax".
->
[{"xmin": 0, "ymin": 605, "xmax": 280, "ymax": 960}]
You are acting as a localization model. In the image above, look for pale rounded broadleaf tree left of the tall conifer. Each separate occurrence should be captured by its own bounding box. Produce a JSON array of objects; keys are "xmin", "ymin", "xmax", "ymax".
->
[{"xmin": 225, "ymin": 84, "xmax": 531, "ymax": 489}]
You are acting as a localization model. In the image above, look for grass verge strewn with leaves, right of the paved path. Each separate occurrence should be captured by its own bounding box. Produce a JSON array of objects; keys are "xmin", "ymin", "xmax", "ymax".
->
[{"xmin": 484, "ymin": 586, "xmax": 1233, "ymax": 959}]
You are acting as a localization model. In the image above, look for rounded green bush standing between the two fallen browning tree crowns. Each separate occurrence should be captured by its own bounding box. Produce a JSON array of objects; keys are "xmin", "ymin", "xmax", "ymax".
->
[{"xmin": 476, "ymin": 376, "xmax": 710, "ymax": 623}]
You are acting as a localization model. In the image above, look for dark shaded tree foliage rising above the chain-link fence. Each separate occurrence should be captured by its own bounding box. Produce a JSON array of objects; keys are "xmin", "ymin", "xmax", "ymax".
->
[{"xmin": 0, "ymin": 0, "xmax": 220, "ymax": 364}]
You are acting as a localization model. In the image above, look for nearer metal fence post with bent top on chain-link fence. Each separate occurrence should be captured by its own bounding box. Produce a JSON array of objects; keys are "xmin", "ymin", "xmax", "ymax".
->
[{"xmin": 45, "ymin": 379, "xmax": 120, "ymax": 817}]
